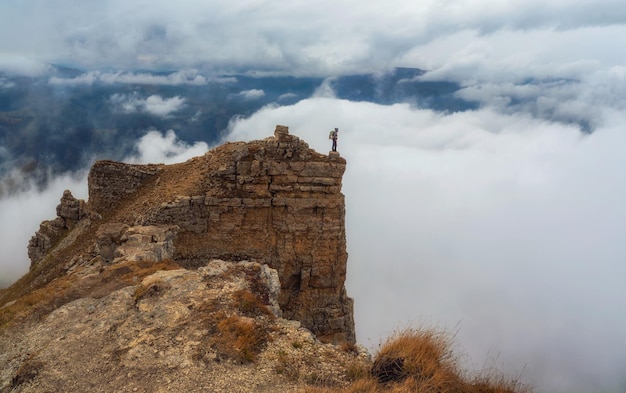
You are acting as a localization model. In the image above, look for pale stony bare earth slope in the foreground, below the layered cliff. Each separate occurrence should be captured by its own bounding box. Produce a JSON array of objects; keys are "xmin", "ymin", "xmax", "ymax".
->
[{"xmin": 0, "ymin": 260, "xmax": 368, "ymax": 392}]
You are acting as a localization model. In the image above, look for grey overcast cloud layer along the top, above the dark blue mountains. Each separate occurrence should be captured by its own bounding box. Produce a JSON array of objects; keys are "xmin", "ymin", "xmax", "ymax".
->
[{"xmin": 0, "ymin": 0, "xmax": 626, "ymax": 75}]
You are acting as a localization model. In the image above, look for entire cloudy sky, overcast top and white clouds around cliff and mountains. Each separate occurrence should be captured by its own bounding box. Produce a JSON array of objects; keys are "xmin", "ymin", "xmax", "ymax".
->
[{"xmin": 0, "ymin": 0, "xmax": 626, "ymax": 393}]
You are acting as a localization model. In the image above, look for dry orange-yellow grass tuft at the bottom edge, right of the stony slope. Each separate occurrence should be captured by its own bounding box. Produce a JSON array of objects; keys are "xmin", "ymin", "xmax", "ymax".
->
[{"xmin": 304, "ymin": 329, "xmax": 532, "ymax": 393}]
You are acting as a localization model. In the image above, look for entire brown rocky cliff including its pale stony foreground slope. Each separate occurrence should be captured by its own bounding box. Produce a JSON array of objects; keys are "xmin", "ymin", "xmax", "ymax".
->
[{"xmin": 0, "ymin": 126, "xmax": 367, "ymax": 391}]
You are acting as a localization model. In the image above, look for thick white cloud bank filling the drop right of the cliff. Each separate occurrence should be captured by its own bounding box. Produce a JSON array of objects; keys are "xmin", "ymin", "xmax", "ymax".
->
[{"xmin": 223, "ymin": 98, "xmax": 626, "ymax": 393}]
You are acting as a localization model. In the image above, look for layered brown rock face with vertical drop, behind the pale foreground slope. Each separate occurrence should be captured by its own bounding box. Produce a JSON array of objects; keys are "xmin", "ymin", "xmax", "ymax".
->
[{"xmin": 61, "ymin": 126, "xmax": 355, "ymax": 343}]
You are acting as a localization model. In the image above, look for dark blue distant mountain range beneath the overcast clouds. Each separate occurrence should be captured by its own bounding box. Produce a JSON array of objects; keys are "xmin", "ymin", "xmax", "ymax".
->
[{"xmin": 0, "ymin": 66, "xmax": 477, "ymax": 195}]
